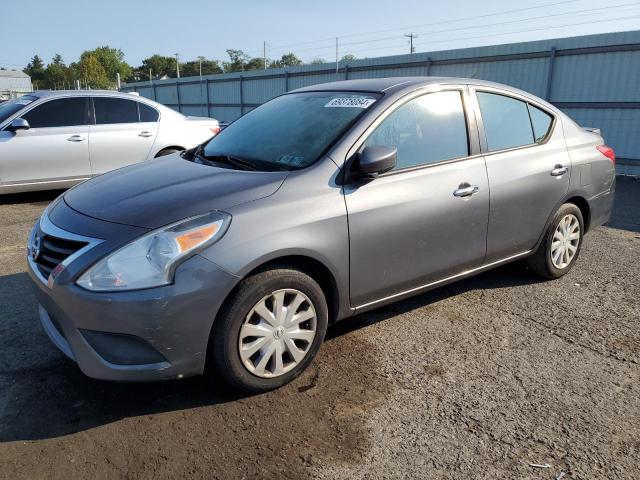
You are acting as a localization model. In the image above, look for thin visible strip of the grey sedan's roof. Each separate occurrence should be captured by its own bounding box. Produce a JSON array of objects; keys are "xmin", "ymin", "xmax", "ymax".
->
[{"xmin": 292, "ymin": 77, "xmax": 531, "ymax": 95}]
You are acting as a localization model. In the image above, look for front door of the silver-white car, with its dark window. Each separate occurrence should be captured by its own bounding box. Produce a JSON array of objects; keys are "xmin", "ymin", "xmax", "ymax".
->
[{"xmin": 0, "ymin": 97, "xmax": 91, "ymax": 188}]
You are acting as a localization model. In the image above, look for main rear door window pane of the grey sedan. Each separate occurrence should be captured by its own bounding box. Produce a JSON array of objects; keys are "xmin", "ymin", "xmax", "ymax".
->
[{"xmin": 477, "ymin": 92, "xmax": 534, "ymax": 152}]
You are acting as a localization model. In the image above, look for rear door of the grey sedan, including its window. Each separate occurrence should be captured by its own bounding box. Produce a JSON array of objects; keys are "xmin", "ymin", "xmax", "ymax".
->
[{"xmin": 472, "ymin": 87, "xmax": 571, "ymax": 263}]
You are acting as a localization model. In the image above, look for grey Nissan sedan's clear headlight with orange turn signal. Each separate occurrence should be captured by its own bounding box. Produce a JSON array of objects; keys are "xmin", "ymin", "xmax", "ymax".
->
[{"xmin": 76, "ymin": 212, "xmax": 231, "ymax": 292}]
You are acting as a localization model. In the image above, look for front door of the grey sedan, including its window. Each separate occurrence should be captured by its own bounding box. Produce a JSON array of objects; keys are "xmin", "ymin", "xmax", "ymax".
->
[{"xmin": 344, "ymin": 90, "xmax": 489, "ymax": 307}]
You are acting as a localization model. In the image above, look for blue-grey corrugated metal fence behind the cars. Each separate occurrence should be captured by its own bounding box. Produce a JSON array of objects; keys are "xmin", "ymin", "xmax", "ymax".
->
[{"xmin": 122, "ymin": 31, "xmax": 640, "ymax": 169}]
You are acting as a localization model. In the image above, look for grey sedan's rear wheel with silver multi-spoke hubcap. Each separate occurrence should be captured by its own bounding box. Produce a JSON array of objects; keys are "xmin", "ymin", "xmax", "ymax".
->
[{"xmin": 527, "ymin": 203, "xmax": 584, "ymax": 279}]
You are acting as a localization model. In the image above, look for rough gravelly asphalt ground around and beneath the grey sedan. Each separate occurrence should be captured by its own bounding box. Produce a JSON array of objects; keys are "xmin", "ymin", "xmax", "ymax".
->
[{"xmin": 0, "ymin": 178, "xmax": 640, "ymax": 479}]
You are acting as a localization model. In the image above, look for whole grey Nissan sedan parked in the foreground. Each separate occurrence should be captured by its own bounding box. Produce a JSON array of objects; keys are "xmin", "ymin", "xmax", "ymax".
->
[{"xmin": 28, "ymin": 77, "xmax": 615, "ymax": 392}]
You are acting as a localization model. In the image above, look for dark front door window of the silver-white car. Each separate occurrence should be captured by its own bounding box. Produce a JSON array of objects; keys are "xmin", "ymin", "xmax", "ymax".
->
[{"xmin": 22, "ymin": 97, "xmax": 87, "ymax": 128}]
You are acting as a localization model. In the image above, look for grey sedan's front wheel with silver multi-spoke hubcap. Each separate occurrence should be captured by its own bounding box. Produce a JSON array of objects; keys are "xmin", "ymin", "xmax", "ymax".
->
[{"xmin": 209, "ymin": 268, "xmax": 328, "ymax": 393}]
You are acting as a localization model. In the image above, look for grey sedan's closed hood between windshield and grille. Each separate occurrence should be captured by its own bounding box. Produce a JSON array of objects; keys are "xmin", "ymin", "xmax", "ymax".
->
[{"xmin": 64, "ymin": 154, "xmax": 288, "ymax": 228}]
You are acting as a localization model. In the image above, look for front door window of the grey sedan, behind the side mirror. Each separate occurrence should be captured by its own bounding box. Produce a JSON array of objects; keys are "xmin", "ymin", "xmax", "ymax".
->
[{"xmin": 365, "ymin": 91, "xmax": 469, "ymax": 170}]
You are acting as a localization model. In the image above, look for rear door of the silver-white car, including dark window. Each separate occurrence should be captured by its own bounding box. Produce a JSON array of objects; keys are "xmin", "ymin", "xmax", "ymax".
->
[{"xmin": 89, "ymin": 96, "xmax": 158, "ymax": 175}]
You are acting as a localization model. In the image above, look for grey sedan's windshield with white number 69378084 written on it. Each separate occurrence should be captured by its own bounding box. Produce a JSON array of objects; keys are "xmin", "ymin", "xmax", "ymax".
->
[{"xmin": 200, "ymin": 92, "xmax": 380, "ymax": 170}]
